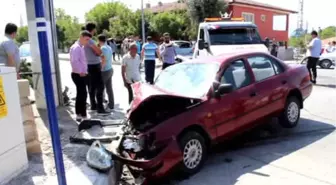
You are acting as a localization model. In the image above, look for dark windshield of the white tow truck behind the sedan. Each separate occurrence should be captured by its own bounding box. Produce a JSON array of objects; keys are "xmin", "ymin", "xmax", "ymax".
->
[{"xmin": 209, "ymin": 27, "xmax": 262, "ymax": 45}]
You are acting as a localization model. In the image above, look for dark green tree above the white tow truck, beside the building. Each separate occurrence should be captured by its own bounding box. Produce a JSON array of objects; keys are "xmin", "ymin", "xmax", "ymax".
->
[{"xmin": 186, "ymin": 0, "xmax": 227, "ymax": 23}]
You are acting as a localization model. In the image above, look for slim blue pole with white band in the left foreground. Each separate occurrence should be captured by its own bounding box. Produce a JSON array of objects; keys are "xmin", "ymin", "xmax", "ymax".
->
[{"xmin": 34, "ymin": 0, "xmax": 66, "ymax": 185}]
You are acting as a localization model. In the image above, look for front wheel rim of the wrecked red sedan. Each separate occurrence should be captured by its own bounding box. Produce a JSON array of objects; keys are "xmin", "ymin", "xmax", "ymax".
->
[{"xmin": 183, "ymin": 139, "xmax": 203, "ymax": 169}]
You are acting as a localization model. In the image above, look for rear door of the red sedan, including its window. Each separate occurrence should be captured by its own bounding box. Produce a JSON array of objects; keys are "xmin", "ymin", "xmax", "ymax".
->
[{"xmin": 247, "ymin": 54, "xmax": 288, "ymax": 120}]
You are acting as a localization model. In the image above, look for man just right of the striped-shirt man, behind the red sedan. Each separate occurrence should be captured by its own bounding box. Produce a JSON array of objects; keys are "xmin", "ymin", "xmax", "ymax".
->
[{"xmin": 160, "ymin": 33, "xmax": 176, "ymax": 70}]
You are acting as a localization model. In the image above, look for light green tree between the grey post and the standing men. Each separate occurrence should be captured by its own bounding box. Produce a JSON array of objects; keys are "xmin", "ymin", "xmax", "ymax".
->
[{"xmin": 55, "ymin": 8, "xmax": 82, "ymax": 47}]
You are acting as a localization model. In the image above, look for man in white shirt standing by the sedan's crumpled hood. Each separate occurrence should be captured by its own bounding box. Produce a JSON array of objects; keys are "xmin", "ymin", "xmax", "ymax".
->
[{"xmin": 121, "ymin": 43, "xmax": 141, "ymax": 103}]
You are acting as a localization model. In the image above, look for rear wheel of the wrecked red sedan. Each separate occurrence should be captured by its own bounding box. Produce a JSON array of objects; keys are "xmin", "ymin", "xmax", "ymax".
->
[{"xmin": 279, "ymin": 96, "xmax": 301, "ymax": 128}]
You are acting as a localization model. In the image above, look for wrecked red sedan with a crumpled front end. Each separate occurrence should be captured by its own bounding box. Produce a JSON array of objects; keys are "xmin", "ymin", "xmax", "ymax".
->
[{"xmin": 107, "ymin": 53, "xmax": 312, "ymax": 183}]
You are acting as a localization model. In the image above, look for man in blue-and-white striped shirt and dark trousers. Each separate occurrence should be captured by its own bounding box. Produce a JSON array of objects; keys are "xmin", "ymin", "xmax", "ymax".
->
[{"xmin": 141, "ymin": 36, "xmax": 161, "ymax": 84}]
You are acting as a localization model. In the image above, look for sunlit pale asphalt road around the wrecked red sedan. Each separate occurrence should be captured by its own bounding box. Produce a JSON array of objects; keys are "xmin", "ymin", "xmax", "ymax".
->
[{"xmin": 60, "ymin": 61, "xmax": 336, "ymax": 185}]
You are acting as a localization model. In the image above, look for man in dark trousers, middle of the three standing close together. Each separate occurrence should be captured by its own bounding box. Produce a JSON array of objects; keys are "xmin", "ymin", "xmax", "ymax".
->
[{"xmin": 84, "ymin": 22, "xmax": 108, "ymax": 114}]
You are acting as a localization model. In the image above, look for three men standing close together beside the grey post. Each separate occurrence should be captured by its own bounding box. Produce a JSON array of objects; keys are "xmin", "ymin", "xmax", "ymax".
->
[{"xmin": 70, "ymin": 23, "xmax": 114, "ymax": 121}]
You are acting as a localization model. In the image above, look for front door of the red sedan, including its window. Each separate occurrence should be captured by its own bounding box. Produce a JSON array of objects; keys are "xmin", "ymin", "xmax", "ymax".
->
[{"xmin": 210, "ymin": 59, "xmax": 256, "ymax": 140}]
